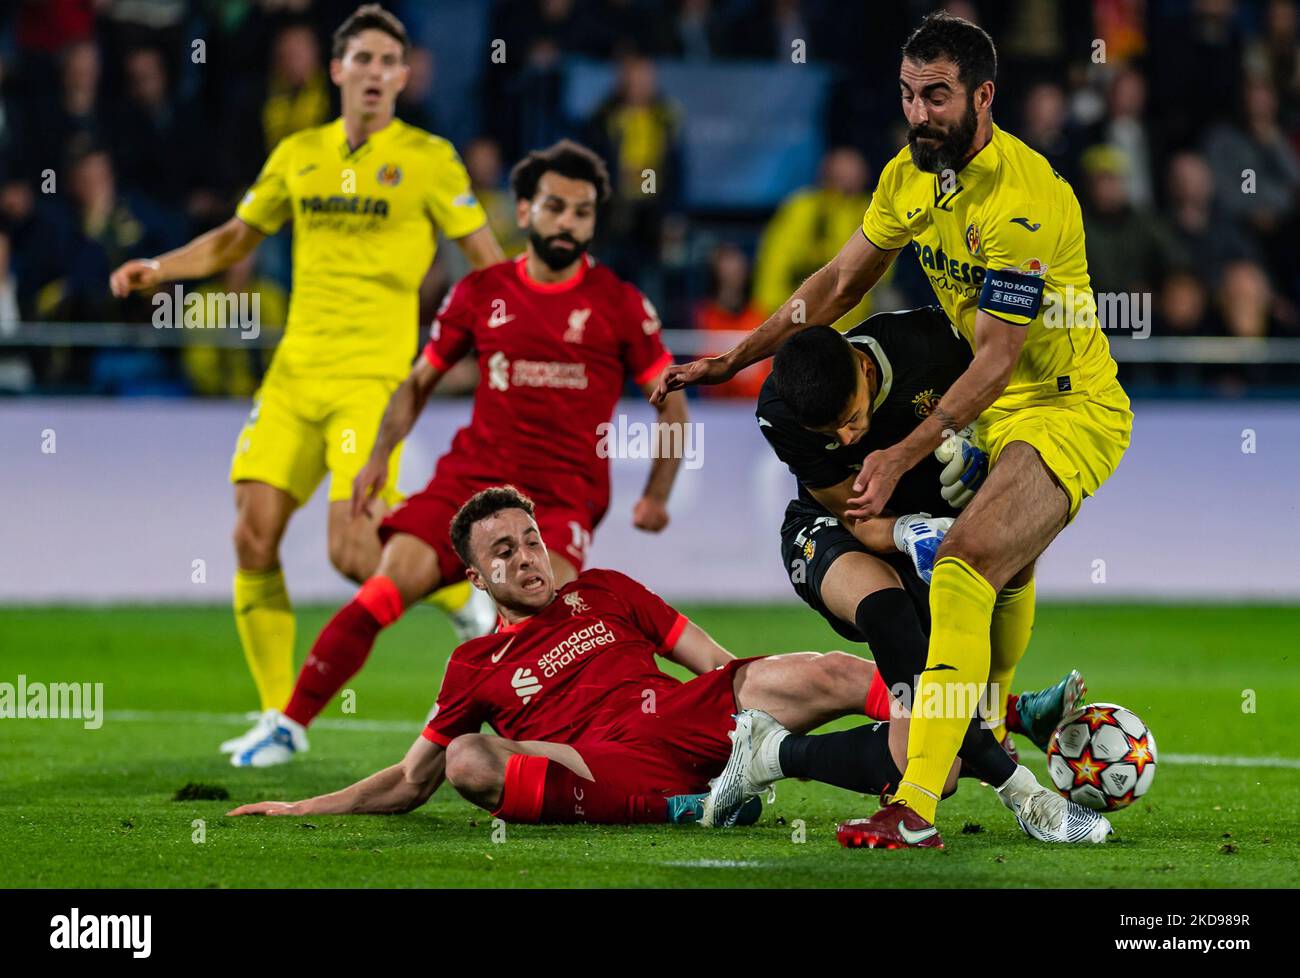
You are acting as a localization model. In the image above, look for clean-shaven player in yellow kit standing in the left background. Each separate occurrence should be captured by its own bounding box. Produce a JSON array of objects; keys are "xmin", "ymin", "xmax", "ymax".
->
[{"xmin": 109, "ymin": 4, "xmax": 504, "ymax": 750}]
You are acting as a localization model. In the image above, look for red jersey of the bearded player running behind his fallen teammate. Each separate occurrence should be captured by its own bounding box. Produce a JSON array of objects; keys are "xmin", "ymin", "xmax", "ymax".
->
[{"xmin": 424, "ymin": 255, "xmax": 672, "ymax": 525}]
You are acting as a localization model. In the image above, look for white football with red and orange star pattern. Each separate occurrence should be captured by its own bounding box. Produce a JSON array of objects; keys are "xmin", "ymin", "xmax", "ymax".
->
[{"xmin": 1048, "ymin": 704, "xmax": 1156, "ymax": 812}]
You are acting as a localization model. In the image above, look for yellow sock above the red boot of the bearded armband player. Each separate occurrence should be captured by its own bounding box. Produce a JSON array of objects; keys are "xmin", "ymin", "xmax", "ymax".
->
[{"xmin": 894, "ymin": 557, "xmax": 997, "ymax": 822}]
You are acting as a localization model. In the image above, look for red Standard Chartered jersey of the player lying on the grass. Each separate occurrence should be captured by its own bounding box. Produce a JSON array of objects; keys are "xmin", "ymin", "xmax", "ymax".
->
[{"xmin": 424, "ymin": 570, "xmax": 686, "ymax": 747}]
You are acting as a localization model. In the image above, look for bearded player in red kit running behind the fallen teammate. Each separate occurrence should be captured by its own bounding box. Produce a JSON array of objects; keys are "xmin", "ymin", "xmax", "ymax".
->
[{"xmin": 230, "ymin": 140, "xmax": 686, "ymax": 767}]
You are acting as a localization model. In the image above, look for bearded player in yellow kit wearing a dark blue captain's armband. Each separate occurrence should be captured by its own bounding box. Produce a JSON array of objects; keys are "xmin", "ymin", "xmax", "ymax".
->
[{"xmin": 657, "ymin": 13, "xmax": 1132, "ymax": 848}]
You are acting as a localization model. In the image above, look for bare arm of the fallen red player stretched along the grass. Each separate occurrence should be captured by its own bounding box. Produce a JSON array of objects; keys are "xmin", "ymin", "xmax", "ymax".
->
[{"xmin": 226, "ymin": 736, "xmax": 447, "ymax": 815}]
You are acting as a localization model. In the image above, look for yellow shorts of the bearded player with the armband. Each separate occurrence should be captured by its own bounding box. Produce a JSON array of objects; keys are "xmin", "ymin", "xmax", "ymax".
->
[{"xmin": 976, "ymin": 380, "xmax": 1134, "ymax": 523}]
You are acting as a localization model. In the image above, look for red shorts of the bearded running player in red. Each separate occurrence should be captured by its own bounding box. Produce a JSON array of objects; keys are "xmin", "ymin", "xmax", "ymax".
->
[{"xmin": 380, "ymin": 475, "xmax": 595, "ymax": 587}]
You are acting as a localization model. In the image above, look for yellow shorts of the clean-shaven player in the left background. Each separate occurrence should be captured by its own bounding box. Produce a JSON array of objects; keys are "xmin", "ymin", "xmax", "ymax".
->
[{"xmin": 230, "ymin": 365, "xmax": 402, "ymax": 506}]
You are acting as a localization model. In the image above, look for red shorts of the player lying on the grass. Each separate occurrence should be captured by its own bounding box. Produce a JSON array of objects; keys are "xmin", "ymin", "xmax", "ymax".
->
[{"xmin": 573, "ymin": 659, "xmax": 753, "ymax": 795}]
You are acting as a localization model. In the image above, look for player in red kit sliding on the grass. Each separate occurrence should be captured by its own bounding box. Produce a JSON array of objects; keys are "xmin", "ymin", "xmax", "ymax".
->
[{"xmin": 230, "ymin": 486, "xmax": 1081, "ymax": 823}]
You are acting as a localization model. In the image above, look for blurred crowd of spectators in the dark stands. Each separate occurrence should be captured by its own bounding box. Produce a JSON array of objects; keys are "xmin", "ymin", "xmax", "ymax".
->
[{"xmin": 0, "ymin": 0, "xmax": 1300, "ymax": 395}]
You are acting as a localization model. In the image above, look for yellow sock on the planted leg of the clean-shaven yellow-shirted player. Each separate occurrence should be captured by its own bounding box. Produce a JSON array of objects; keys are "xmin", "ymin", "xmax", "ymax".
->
[{"xmin": 234, "ymin": 567, "xmax": 296, "ymax": 710}]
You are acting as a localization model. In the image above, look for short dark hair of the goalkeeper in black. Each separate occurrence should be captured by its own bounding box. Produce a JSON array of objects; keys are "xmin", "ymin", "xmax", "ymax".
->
[{"xmin": 772, "ymin": 326, "xmax": 858, "ymax": 428}]
